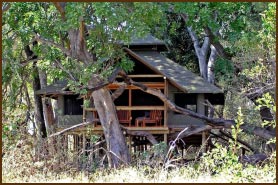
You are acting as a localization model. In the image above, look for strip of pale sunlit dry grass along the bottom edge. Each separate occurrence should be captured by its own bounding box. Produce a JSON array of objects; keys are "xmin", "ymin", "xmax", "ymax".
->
[{"xmin": 2, "ymin": 167, "xmax": 275, "ymax": 183}]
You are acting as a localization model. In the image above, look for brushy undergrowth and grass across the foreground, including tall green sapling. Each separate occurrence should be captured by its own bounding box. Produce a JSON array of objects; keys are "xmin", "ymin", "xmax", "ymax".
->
[{"xmin": 2, "ymin": 105, "xmax": 276, "ymax": 183}]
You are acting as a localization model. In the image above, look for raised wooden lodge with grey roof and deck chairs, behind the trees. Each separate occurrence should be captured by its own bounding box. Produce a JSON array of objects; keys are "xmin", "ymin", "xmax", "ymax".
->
[{"xmin": 36, "ymin": 35, "xmax": 224, "ymax": 154}]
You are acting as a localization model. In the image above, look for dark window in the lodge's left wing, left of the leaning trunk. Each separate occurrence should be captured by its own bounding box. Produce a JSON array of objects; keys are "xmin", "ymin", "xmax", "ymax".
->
[{"xmin": 64, "ymin": 95, "xmax": 83, "ymax": 115}]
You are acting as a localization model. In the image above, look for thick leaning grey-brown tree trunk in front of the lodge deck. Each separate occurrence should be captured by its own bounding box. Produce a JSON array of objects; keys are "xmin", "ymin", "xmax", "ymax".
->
[{"xmin": 92, "ymin": 88, "xmax": 130, "ymax": 168}]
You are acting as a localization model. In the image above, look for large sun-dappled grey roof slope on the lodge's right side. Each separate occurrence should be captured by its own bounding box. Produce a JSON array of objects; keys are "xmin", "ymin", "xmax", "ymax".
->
[{"xmin": 129, "ymin": 50, "xmax": 223, "ymax": 94}]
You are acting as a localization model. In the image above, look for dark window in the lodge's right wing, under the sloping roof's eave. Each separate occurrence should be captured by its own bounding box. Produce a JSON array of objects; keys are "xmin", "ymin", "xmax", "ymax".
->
[{"xmin": 174, "ymin": 93, "xmax": 197, "ymax": 112}]
